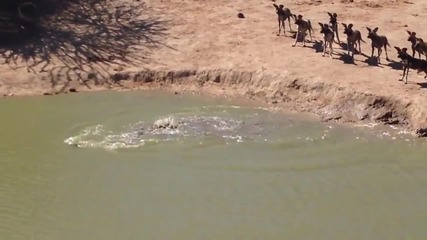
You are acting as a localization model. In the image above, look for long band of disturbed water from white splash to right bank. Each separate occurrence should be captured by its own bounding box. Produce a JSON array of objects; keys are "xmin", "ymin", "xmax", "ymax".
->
[{"xmin": 64, "ymin": 105, "xmax": 424, "ymax": 150}]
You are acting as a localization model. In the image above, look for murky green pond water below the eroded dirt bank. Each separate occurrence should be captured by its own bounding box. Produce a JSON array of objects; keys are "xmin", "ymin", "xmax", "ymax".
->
[{"xmin": 0, "ymin": 92, "xmax": 427, "ymax": 240}]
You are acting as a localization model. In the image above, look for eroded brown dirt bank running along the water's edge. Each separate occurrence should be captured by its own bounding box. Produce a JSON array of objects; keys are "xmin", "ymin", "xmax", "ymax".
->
[{"xmin": 1, "ymin": 69, "xmax": 427, "ymax": 137}]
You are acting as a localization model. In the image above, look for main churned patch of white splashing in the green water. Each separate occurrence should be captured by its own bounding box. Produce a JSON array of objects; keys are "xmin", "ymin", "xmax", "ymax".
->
[{"xmin": 64, "ymin": 114, "xmax": 264, "ymax": 150}]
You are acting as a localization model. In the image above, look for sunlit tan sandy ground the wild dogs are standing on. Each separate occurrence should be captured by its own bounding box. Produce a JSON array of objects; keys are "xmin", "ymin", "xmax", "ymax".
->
[{"xmin": 0, "ymin": 0, "xmax": 427, "ymax": 135}]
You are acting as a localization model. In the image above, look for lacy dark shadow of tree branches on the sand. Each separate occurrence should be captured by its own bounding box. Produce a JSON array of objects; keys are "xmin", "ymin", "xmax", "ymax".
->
[{"xmin": 0, "ymin": 0, "xmax": 167, "ymax": 90}]
